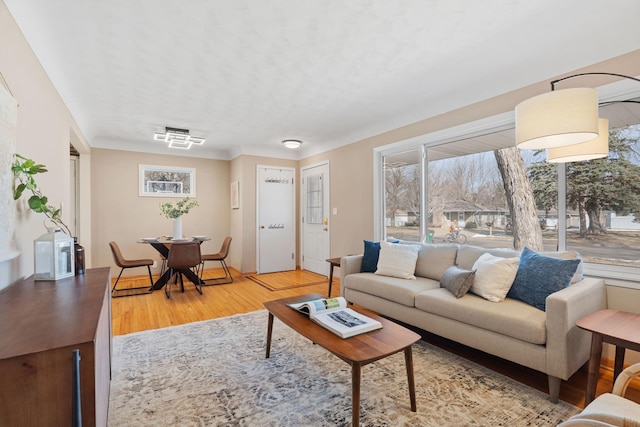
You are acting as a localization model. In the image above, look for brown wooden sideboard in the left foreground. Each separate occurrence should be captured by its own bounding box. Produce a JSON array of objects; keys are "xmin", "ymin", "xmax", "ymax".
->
[{"xmin": 0, "ymin": 267, "xmax": 112, "ymax": 427}]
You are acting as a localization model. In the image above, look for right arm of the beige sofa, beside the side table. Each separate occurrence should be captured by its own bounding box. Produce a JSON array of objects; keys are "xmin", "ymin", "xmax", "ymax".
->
[{"xmin": 546, "ymin": 278, "xmax": 607, "ymax": 380}]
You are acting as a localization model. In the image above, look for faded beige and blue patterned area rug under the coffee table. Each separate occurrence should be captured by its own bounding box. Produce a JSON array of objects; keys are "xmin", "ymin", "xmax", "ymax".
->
[{"xmin": 109, "ymin": 310, "xmax": 580, "ymax": 427}]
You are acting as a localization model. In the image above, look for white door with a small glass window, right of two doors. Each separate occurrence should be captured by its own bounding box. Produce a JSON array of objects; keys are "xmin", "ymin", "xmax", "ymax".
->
[{"xmin": 300, "ymin": 163, "xmax": 331, "ymax": 276}]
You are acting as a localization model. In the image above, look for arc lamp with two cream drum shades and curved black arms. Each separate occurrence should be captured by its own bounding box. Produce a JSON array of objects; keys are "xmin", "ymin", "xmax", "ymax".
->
[{"xmin": 515, "ymin": 73, "xmax": 640, "ymax": 163}]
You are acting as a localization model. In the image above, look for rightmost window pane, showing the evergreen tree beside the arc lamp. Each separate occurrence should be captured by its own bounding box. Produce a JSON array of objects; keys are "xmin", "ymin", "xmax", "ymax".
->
[{"xmin": 566, "ymin": 125, "xmax": 640, "ymax": 266}]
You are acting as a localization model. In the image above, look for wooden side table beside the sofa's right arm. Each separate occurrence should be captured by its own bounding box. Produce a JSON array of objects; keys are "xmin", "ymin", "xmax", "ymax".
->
[{"xmin": 576, "ymin": 310, "xmax": 640, "ymax": 406}]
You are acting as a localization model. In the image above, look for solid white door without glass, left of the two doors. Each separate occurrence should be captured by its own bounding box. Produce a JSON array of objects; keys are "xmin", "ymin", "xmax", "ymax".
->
[{"xmin": 256, "ymin": 166, "xmax": 296, "ymax": 274}]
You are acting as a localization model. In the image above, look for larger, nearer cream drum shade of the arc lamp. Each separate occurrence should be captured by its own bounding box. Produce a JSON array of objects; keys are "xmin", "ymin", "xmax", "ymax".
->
[{"xmin": 515, "ymin": 88, "xmax": 598, "ymax": 150}]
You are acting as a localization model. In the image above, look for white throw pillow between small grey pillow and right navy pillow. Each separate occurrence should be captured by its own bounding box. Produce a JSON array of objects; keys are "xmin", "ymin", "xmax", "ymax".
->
[{"xmin": 469, "ymin": 252, "xmax": 520, "ymax": 302}]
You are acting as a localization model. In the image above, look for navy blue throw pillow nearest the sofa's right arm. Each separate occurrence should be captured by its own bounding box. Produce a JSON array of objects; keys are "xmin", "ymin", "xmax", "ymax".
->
[{"xmin": 507, "ymin": 247, "xmax": 580, "ymax": 311}]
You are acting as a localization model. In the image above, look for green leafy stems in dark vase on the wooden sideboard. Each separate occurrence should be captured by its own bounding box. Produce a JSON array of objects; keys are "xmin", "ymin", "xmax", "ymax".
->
[{"xmin": 11, "ymin": 153, "xmax": 84, "ymax": 275}]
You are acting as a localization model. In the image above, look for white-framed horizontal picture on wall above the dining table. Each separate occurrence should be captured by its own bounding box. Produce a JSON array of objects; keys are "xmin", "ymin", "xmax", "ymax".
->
[{"xmin": 139, "ymin": 165, "xmax": 196, "ymax": 197}]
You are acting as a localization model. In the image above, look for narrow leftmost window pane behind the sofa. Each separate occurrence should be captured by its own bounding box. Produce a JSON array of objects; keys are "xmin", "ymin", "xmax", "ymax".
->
[{"xmin": 384, "ymin": 150, "xmax": 421, "ymax": 242}]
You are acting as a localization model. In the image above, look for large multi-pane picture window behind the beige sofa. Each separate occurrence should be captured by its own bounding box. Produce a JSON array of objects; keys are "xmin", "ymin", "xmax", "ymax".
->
[{"xmin": 378, "ymin": 98, "xmax": 640, "ymax": 268}]
